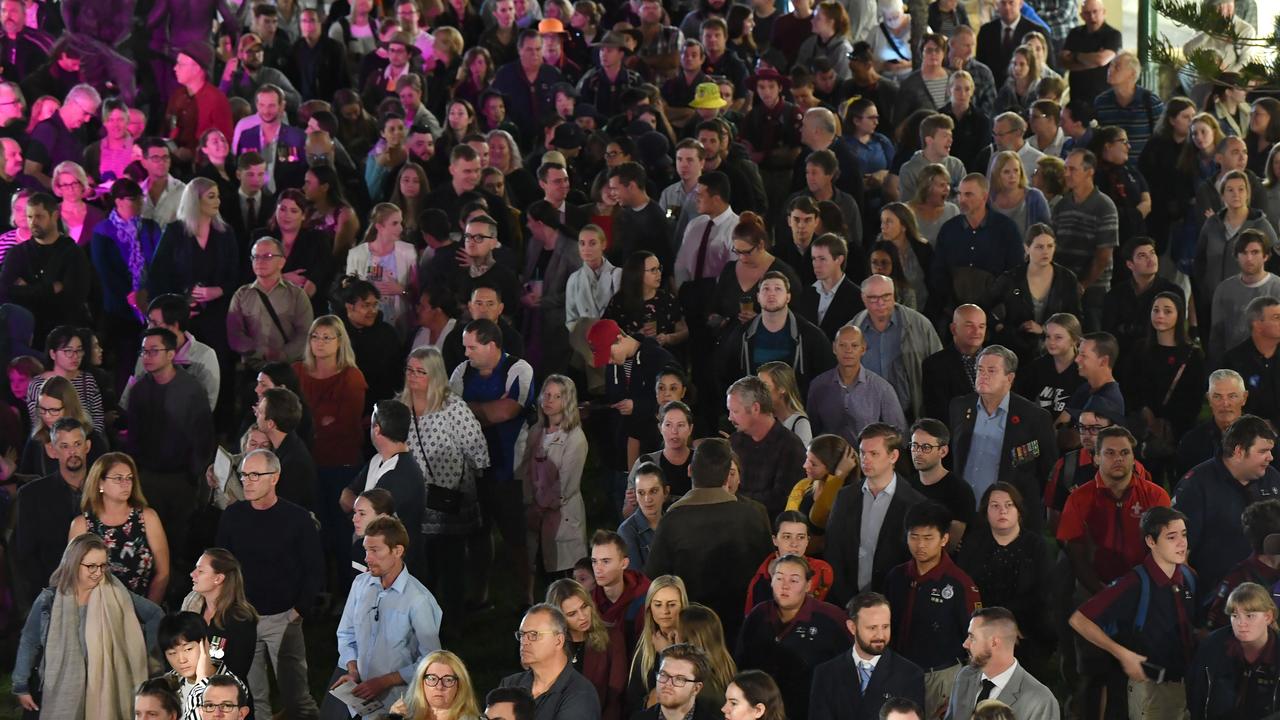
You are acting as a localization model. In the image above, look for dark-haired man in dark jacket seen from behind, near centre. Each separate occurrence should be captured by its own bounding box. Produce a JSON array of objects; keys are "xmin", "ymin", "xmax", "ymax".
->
[{"xmin": 645, "ymin": 438, "xmax": 772, "ymax": 637}]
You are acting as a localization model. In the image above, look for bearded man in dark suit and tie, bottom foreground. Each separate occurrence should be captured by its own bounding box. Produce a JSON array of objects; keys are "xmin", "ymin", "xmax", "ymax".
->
[{"xmin": 809, "ymin": 592, "xmax": 924, "ymax": 720}]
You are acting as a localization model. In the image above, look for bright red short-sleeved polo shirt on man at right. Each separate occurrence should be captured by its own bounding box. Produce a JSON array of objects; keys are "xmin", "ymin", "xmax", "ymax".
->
[{"xmin": 1057, "ymin": 471, "xmax": 1170, "ymax": 583}]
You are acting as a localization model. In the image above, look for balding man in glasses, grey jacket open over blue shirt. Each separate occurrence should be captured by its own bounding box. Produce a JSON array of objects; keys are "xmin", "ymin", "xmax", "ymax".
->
[{"xmin": 849, "ymin": 275, "xmax": 942, "ymax": 418}]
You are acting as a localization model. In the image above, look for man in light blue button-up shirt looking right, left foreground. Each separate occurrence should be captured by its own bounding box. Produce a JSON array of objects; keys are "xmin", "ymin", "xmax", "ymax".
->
[{"xmin": 320, "ymin": 518, "xmax": 443, "ymax": 720}]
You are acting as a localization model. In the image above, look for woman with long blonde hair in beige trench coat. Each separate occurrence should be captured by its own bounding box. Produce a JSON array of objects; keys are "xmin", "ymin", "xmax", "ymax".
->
[{"xmin": 522, "ymin": 375, "xmax": 588, "ymax": 573}]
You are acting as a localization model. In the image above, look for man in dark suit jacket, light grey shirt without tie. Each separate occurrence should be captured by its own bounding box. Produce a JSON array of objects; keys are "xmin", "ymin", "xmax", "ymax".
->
[{"xmin": 824, "ymin": 423, "xmax": 924, "ymax": 603}]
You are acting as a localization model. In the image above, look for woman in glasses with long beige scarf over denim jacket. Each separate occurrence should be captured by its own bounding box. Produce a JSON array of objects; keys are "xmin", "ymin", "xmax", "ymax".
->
[{"xmin": 13, "ymin": 533, "xmax": 164, "ymax": 720}]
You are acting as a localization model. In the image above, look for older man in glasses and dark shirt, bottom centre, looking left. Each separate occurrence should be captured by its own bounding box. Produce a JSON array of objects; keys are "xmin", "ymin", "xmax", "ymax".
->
[{"xmin": 500, "ymin": 602, "xmax": 600, "ymax": 720}]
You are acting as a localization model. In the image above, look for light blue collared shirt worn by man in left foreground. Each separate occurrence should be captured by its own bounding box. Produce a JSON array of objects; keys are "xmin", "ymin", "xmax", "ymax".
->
[{"xmin": 338, "ymin": 568, "xmax": 442, "ymax": 706}]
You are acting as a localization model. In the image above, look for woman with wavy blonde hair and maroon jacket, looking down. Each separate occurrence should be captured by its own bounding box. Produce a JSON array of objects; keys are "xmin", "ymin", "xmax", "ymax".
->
[{"xmin": 547, "ymin": 578, "xmax": 627, "ymax": 720}]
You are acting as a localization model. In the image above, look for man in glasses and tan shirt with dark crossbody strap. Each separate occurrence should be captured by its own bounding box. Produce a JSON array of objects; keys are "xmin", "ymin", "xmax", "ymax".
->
[{"xmin": 227, "ymin": 237, "xmax": 314, "ymax": 368}]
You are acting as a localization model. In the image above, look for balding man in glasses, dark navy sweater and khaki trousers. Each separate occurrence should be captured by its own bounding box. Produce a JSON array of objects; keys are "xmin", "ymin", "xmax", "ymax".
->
[{"xmin": 216, "ymin": 450, "xmax": 325, "ymax": 717}]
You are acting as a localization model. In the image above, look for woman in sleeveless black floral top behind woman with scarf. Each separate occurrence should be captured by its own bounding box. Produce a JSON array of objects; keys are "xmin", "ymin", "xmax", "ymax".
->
[{"xmin": 68, "ymin": 452, "xmax": 169, "ymax": 603}]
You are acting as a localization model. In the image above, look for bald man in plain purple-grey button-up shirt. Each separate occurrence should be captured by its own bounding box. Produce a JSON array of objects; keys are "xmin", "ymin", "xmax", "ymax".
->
[{"xmin": 805, "ymin": 325, "xmax": 906, "ymax": 445}]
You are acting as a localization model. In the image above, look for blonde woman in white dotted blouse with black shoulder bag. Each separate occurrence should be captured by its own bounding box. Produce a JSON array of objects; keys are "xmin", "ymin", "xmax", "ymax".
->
[{"xmin": 399, "ymin": 347, "xmax": 489, "ymax": 623}]
